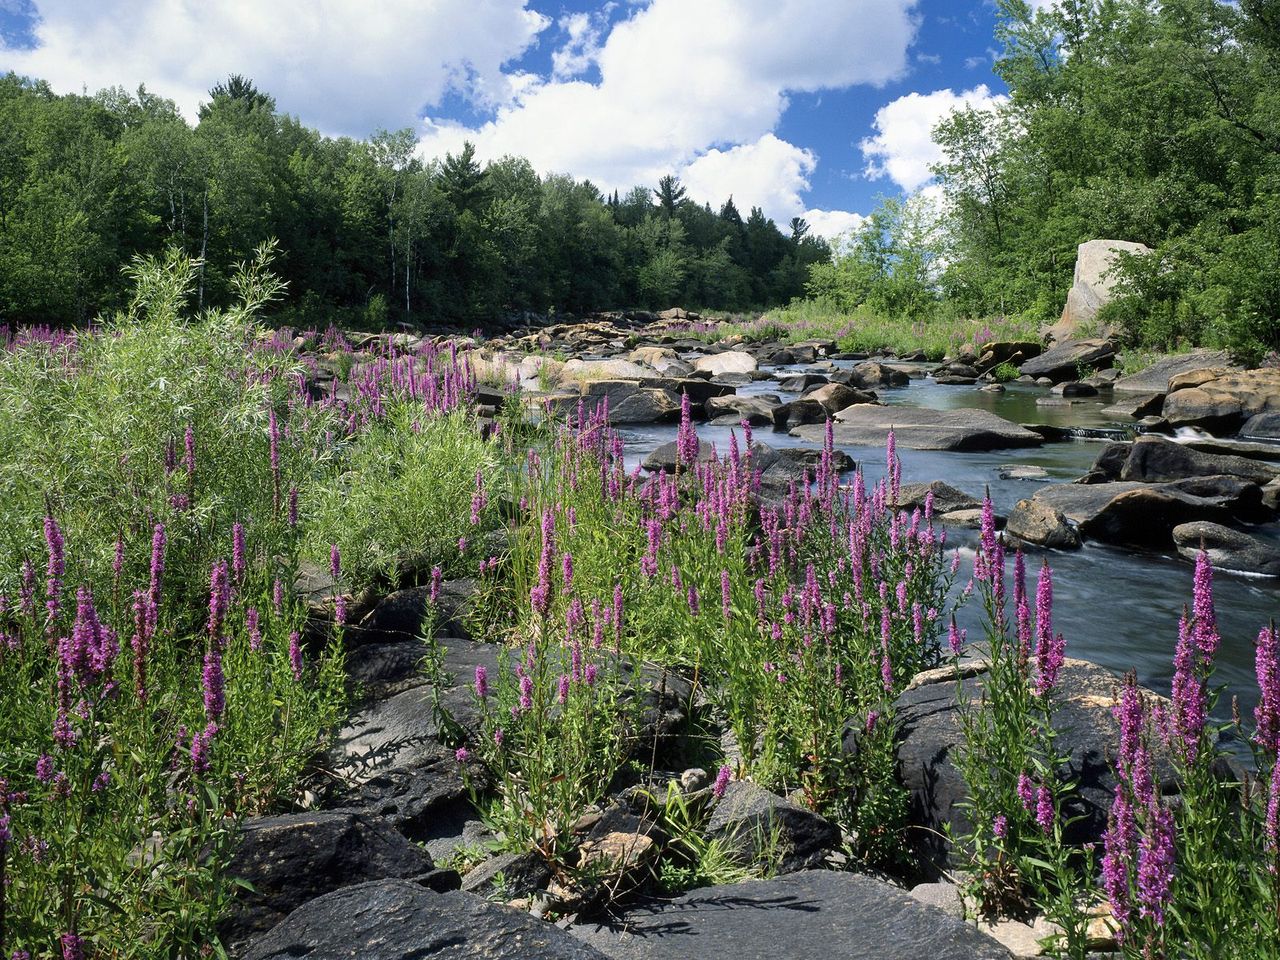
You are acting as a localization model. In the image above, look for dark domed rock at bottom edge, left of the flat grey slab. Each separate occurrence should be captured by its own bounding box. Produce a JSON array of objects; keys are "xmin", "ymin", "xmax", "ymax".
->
[{"xmin": 244, "ymin": 879, "xmax": 614, "ymax": 960}]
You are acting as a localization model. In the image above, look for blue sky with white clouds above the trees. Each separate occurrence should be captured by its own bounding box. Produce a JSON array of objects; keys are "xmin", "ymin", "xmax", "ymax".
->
[{"xmin": 0, "ymin": 0, "xmax": 1043, "ymax": 237}]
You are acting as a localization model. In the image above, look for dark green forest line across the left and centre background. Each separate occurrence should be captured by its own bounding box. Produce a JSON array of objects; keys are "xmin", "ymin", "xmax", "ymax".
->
[{"xmin": 0, "ymin": 73, "xmax": 829, "ymax": 326}]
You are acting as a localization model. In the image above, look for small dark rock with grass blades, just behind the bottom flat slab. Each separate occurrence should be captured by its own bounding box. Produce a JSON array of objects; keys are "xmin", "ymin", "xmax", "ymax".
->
[{"xmin": 707, "ymin": 780, "xmax": 840, "ymax": 873}]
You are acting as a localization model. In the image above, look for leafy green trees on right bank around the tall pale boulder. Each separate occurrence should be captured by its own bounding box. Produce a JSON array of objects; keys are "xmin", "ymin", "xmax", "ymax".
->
[{"xmin": 809, "ymin": 0, "xmax": 1280, "ymax": 358}]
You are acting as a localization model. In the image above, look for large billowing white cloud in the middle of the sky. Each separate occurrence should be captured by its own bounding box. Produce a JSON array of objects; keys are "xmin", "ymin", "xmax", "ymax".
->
[{"xmin": 420, "ymin": 0, "xmax": 916, "ymax": 216}]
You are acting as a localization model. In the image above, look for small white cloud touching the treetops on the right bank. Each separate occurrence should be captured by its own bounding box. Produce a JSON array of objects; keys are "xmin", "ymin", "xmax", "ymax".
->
[{"xmin": 861, "ymin": 83, "xmax": 1009, "ymax": 192}]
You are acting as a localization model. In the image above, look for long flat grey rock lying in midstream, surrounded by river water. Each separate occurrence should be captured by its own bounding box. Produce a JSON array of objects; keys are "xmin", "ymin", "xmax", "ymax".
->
[{"xmin": 792, "ymin": 403, "xmax": 1042, "ymax": 451}]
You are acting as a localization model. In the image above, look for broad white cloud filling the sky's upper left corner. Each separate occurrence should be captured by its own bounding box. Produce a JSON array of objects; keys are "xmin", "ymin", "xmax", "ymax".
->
[{"xmin": 0, "ymin": 0, "xmax": 550, "ymax": 136}]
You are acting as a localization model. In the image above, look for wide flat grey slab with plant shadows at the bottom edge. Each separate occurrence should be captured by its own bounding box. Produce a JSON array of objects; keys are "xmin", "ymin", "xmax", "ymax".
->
[{"xmin": 573, "ymin": 870, "xmax": 1009, "ymax": 960}]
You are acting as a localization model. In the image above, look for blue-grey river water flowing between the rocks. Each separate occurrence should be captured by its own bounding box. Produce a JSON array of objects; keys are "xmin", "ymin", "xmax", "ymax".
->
[{"xmin": 622, "ymin": 367, "xmax": 1280, "ymax": 716}]
